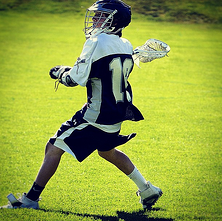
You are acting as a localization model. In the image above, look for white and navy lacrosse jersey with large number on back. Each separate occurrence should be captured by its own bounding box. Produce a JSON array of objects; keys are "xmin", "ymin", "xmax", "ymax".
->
[{"xmin": 69, "ymin": 33, "xmax": 141, "ymax": 131}]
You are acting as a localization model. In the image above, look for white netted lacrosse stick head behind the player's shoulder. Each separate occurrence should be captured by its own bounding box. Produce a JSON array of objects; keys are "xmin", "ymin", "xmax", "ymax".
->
[{"xmin": 133, "ymin": 39, "xmax": 170, "ymax": 67}]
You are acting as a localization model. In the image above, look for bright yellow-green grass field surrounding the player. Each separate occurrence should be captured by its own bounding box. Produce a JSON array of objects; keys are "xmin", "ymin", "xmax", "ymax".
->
[{"xmin": 0, "ymin": 8, "xmax": 222, "ymax": 221}]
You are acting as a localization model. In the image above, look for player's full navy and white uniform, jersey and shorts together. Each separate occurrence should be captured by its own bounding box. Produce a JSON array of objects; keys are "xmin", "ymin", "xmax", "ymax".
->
[{"xmin": 49, "ymin": 33, "xmax": 143, "ymax": 162}]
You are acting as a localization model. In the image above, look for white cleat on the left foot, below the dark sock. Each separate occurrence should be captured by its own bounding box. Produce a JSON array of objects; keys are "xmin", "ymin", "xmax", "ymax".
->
[{"xmin": 0, "ymin": 193, "xmax": 39, "ymax": 209}]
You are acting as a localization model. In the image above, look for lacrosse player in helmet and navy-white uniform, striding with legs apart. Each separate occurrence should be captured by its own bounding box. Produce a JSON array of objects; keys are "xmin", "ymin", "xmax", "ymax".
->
[{"xmin": 0, "ymin": 0, "xmax": 162, "ymax": 209}]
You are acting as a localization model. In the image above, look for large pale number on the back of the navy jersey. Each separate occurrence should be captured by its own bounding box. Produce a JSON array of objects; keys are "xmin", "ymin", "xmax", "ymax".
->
[{"xmin": 109, "ymin": 57, "xmax": 133, "ymax": 103}]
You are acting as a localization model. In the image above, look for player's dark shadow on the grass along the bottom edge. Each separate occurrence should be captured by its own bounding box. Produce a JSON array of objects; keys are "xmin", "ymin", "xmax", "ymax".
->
[{"xmin": 40, "ymin": 208, "xmax": 173, "ymax": 221}]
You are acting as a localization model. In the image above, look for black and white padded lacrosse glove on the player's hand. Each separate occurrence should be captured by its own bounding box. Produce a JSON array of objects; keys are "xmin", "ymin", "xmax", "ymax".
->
[{"xmin": 49, "ymin": 65, "xmax": 78, "ymax": 87}]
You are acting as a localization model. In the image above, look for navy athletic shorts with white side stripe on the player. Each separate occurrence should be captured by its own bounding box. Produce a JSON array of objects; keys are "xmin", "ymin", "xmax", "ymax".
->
[{"xmin": 49, "ymin": 111, "xmax": 136, "ymax": 162}]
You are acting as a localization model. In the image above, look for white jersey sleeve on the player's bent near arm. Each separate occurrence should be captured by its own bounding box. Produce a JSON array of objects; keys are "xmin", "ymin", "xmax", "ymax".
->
[{"xmin": 70, "ymin": 39, "xmax": 97, "ymax": 87}]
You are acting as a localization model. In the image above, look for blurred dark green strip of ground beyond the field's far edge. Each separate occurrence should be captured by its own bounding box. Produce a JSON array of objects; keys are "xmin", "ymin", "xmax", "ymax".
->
[{"xmin": 0, "ymin": 0, "xmax": 222, "ymax": 23}]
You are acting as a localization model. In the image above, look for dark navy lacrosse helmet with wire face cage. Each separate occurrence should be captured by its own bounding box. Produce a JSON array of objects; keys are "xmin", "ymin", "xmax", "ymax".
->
[{"xmin": 84, "ymin": 0, "xmax": 131, "ymax": 38}]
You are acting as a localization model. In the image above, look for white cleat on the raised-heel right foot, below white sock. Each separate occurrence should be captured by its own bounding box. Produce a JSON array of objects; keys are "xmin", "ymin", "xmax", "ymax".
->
[{"xmin": 137, "ymin": 181, "xmax": 163, "ymax": 210}]
